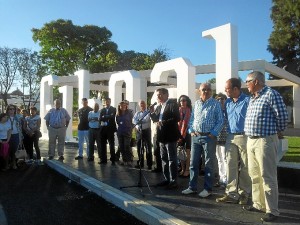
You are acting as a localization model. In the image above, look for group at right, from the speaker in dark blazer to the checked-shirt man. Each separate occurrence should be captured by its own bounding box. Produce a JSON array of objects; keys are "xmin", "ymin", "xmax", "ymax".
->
[{"xmin": 150, "ymin": 71, "xmax": 288, "ymax": 222}]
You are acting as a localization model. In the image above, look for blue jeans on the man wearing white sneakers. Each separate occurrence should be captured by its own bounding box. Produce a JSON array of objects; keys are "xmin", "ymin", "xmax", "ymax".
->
[{"xmin": 189, "ymin": 136, "xmax": 216, "ymax": 191}]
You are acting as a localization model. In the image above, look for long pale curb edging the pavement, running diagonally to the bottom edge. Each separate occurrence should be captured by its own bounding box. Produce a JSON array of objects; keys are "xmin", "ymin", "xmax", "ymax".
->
[{"xmin": 45, "ymin": 160, "xmax": 188, "ymax": 225}]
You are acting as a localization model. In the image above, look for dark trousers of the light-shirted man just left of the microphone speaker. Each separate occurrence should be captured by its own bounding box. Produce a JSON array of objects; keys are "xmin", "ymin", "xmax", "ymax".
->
[{"xmin": 137, "ymin": 128, "xmax": 152, "ymax": 167}]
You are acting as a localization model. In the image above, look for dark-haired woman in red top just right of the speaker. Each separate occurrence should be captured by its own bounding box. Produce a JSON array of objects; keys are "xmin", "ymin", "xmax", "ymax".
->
[{"xmin": 177, "ymin": 95, "xmax": 192, "ymax": 177}]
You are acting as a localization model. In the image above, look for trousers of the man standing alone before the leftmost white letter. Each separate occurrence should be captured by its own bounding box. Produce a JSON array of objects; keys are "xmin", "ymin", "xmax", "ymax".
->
[{"xmin": 48, "ymin": 127, "xmax": 67, "ymax": 157}]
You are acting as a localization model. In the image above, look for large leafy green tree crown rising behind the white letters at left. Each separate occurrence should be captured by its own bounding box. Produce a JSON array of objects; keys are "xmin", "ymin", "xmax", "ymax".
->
[{"xmin": 32, "ymin": 19, "xmax": 117, "ymax": 76}]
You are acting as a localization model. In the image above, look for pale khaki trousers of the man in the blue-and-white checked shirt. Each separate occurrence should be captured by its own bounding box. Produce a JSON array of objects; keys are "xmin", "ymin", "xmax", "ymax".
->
[{"xmin": 247, "ymin": 134, "xmax": 279, "ymax": 216}]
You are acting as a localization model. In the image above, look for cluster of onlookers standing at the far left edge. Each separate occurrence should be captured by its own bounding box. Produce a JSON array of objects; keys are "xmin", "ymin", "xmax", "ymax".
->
[{"xmin": 0, "ymin": 105, "xmax": 41, "ymax": 171}]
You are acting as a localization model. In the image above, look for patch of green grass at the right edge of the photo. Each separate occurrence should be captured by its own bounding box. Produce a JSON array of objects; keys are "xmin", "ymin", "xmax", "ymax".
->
[{"xmin": 281, "ymin": 137, "xmax": 300, "ymax": 163}]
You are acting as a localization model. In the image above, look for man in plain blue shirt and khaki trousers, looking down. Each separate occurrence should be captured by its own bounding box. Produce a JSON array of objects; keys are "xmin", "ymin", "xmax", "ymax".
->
[{"xmin": 216, "ymin": 78, "xmax": 251, "ymax": 205}]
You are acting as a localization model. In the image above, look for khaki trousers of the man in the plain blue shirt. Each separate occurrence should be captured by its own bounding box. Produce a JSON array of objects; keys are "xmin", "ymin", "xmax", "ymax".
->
[{"xmin": 225, "ymin": 134, "xmax": 251, "ymax": 200}]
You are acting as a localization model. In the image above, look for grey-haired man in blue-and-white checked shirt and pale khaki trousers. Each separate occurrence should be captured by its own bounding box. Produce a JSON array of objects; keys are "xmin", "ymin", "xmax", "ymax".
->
[{"xmin": 244, "ymin": 71, "xmax": 288, "ymax": 222}]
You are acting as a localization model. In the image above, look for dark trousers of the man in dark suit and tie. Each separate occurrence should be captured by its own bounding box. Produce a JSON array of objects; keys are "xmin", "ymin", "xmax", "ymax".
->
[{"xmin": 100, "ymin": 128, "xmax": 115, "ymax": 162}]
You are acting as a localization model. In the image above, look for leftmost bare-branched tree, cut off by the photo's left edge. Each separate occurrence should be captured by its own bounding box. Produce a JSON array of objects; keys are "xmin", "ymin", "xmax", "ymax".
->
[{"xmin": 0, "ymin": 47, "xmax": 22, "ymax": 107}]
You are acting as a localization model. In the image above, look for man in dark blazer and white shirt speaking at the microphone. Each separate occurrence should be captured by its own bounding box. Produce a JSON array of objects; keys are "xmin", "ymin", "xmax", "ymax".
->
[{"xmin": 150, "ymin": 88, "xmax": 180, "ymax": 189}]
